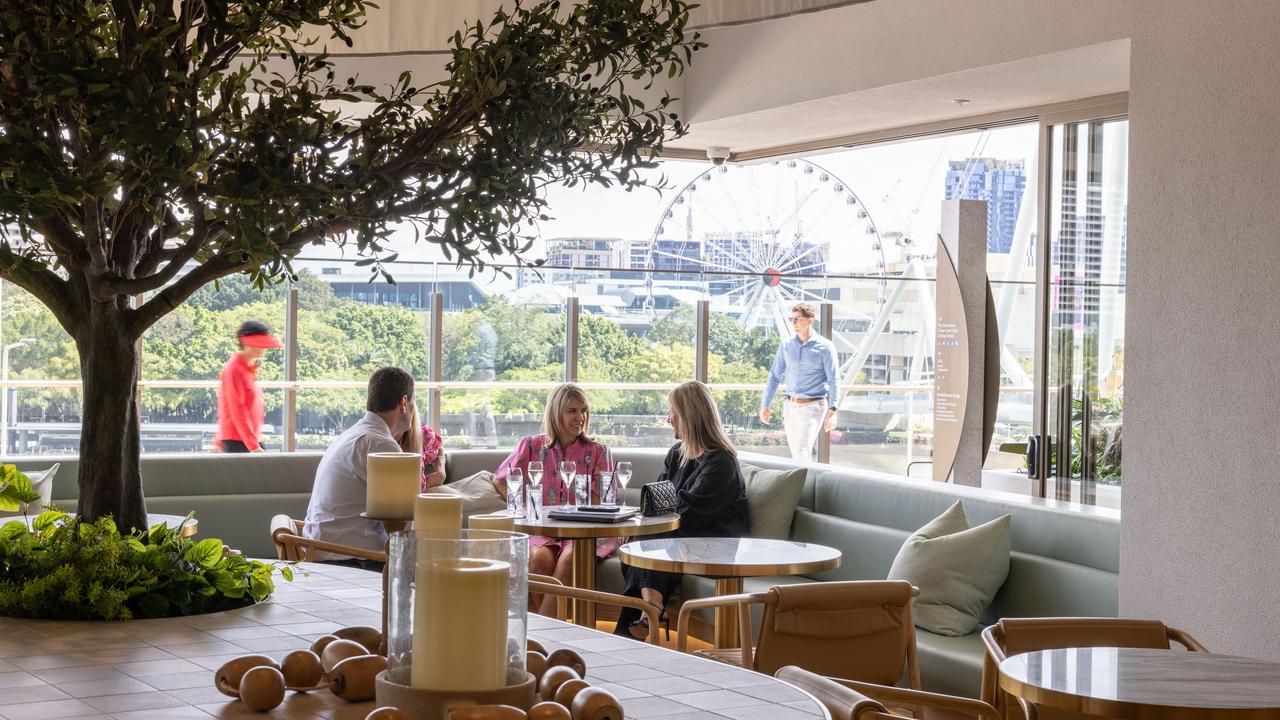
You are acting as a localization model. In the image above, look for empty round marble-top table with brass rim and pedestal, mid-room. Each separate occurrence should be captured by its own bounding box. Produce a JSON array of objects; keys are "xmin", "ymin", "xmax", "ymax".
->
[{"xmin": 621, "ymin": 538, "xmax": 841, "ymax": 647}]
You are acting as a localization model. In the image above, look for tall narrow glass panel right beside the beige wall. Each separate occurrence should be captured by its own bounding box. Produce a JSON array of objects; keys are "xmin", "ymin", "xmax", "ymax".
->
[{"xmin": 1046, "ymin": 120, "xmax": 1129, "ymax": 506}]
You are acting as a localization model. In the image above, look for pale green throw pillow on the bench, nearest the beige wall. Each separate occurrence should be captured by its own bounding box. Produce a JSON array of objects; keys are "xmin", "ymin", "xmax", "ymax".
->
[{"xmin": 888, "ymin": 501, "xmax": 1010, "ymax": 637}]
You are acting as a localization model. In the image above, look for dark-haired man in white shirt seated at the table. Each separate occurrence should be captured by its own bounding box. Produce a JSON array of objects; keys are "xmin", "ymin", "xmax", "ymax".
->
[{"xmin": 302, "ymin": 368, "xmax": 413, "ymax": 570}]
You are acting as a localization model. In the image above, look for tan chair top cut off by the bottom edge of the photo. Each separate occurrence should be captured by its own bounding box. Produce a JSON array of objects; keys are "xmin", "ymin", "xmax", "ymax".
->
[{"xmin": 774, "ymin": 665, "xmax": 1000, "ymax": 720}]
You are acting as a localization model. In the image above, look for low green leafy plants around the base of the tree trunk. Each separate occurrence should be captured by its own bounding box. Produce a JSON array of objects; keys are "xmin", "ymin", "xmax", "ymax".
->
[{"xmin": 0, "ymin": 510, "xmax": 282, "ymax": 620}]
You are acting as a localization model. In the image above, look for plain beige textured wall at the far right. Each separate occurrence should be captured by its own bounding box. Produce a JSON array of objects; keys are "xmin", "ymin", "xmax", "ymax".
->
[{"xmin": 1120, "ymin": 0, "xmax": 1280, "ymax": 660}]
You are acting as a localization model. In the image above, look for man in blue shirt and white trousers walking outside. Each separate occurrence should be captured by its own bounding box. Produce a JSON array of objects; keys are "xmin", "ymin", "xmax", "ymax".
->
[{"xmin": 760, "ymin": 302, "xmax": 840, "ymax": 460}]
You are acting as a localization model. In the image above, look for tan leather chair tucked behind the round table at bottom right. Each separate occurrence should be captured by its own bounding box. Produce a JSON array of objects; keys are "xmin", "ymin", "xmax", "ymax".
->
[{"xmin": 982, "ymin": 618, "xmax": 1208, "ymax": 720}]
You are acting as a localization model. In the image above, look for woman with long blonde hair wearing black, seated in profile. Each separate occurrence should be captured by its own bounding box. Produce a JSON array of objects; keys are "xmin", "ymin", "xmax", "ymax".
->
[{"xmin": 613, "ymin": 382, "xmax": 750, "ymax": 638}]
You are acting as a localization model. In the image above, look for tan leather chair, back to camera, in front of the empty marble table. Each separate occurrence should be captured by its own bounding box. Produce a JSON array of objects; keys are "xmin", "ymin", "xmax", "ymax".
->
[{"xmin": 676, "ymin": 580, "xmax": 920, "ymax": 688}]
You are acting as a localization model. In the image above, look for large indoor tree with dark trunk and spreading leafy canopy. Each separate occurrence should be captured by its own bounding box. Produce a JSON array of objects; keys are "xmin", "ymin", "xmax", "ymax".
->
[{"xmin": 0, "ymin": 0, "xmax": 700, "ymax": 528}]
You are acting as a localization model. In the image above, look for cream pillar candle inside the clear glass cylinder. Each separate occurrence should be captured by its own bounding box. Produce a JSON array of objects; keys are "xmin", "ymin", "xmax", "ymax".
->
[{"xmin": 410, "ymin": 557, "xmax": 511, "ymax": 691}]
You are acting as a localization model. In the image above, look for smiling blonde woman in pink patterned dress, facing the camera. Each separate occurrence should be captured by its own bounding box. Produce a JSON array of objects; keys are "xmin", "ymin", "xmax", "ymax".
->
[{"xmin": 494, "ymin": 383, "xmax": 622, "ymax": 615}]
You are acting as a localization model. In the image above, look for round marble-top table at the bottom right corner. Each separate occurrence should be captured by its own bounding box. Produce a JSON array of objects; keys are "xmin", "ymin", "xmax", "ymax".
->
[{"xmin": 1000, "ymin": 647, "xmax": 1280, "ymax": 720}]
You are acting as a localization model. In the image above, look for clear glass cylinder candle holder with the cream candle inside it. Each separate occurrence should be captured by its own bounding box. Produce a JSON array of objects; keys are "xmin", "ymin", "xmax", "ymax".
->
[{"xmin": 387, "ymin": 530, "xmax": 529, "ymax": 692}]
